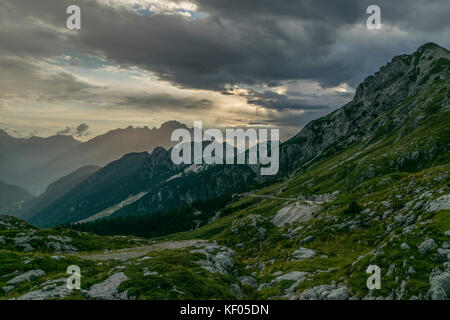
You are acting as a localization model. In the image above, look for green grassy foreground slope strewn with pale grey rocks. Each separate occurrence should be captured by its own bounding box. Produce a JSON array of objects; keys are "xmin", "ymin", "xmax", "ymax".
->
[{"xmin": 0, "ymin": 167, "xmax": 450, "ymax": 300}]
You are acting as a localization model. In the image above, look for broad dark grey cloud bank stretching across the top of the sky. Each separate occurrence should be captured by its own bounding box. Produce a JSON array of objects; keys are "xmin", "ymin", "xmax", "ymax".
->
[{"xmin": 0, "ymin": 0, "xmax": 450, "ymax": 114}]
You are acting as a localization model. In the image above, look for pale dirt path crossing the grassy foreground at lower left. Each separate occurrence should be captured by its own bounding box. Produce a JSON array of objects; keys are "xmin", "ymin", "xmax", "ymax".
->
[{"xmin": 79, "ymin": 240, "xmax": 205, "ymax": 260}]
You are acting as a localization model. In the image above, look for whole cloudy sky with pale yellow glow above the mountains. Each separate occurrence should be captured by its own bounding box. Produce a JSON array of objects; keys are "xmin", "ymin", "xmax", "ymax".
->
[{"xmin": 0, "ymin": 0, "xmax": 450, "ymax": 140}]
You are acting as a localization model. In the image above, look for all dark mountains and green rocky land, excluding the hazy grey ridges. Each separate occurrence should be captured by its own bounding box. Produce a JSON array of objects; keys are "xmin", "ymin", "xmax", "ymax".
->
[{"xmin": 0, "ymin": 43, "xmax": 450, "ymax": 300}]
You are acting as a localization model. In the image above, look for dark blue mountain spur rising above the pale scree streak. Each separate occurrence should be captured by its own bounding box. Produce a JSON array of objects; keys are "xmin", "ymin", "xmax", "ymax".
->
[{"xmin": 30, "ymin": 147, "xmax": 177, "ymax": 226}]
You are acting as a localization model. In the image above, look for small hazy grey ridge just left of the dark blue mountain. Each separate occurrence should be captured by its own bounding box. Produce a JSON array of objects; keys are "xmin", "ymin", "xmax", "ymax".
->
[{"xmin": 16, "ymin": 166, "xmax": 100, "ymax": 220}]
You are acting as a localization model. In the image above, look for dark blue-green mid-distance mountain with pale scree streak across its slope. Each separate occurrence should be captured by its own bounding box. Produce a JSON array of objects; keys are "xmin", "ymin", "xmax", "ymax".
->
[{"xmin": 29, "ymin": 143, "xmax": 258, "ymax": 227}]
